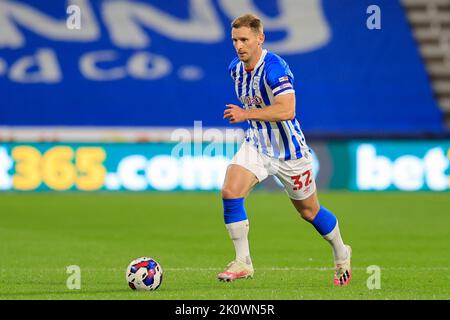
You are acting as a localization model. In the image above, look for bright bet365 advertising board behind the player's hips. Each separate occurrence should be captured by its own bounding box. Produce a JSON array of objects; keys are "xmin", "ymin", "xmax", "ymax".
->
[{"xmin": 0, "ymin": 140, "xmax": 450, "ymax": 192}]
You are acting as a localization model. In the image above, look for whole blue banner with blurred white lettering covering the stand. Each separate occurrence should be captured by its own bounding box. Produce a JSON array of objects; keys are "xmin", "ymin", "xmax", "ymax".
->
[{"xmin": 0, "ymin": 0, "xmax": 444, "ymax": 135}]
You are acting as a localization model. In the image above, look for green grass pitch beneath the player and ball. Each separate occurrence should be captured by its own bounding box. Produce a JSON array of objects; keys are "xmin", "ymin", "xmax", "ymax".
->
[{"xmin": 0, "ymin": 192, "xmax": 450, "ymax": 300}]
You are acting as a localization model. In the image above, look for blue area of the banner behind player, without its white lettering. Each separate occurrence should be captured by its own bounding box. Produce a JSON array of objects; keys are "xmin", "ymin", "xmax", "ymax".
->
[{"xmin": 0, "ymin": 0, "xmax": 443, "ymax": 134}]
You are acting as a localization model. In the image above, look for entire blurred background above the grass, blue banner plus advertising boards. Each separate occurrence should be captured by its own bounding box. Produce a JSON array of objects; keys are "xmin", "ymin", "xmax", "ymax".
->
[{"xmin": 0, "ymin": 0, "xmax": 450, "ymax": 192}]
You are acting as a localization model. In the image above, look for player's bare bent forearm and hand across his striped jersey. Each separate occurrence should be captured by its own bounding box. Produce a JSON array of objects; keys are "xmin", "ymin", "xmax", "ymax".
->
[{"xmin": 223, "ymin": 93, "xmax": 295, "ymax": 123}]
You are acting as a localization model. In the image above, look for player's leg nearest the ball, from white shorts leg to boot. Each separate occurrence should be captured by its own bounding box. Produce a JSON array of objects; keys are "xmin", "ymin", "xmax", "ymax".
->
[{"xmin": 218, "ymin": 143, "xmax": 267, "ymax": 281}]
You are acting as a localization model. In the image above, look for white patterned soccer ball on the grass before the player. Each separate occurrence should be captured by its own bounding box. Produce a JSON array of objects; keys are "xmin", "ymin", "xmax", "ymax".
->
[{"xmin": 125, "ymin": 257, "xmax": 163, "ymax": 290}]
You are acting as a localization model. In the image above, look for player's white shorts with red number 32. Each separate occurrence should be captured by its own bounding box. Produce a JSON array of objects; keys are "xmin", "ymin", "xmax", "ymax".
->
[{"xmin": 230, "ymin": 141, "xmax": 316, "ymax": 200}]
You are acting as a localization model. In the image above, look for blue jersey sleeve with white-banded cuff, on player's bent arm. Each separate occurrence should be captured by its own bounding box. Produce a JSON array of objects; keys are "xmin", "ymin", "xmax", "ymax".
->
[{"xmin": 266, "ymin": 60, "xmax": 295, "ymax": 96}]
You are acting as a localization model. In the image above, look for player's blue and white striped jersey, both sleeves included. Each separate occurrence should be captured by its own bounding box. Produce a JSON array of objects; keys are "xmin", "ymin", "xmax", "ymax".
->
[{"xmin": 229, "ymin": 50, "xmax": 309, "ymax": 160}]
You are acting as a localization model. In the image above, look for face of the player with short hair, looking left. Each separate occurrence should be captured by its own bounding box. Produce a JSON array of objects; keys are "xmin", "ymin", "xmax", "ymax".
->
[{"xmin": 231, "ymin": 27, "xmax": 264, "ymax": 63}]
